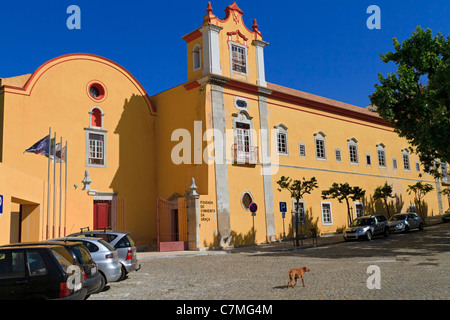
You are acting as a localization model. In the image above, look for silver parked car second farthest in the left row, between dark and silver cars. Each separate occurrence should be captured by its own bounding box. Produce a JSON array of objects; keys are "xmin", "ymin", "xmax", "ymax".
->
[{"xmin": 54, "ymin": 237, "xmax": 122, "ymax": 286}]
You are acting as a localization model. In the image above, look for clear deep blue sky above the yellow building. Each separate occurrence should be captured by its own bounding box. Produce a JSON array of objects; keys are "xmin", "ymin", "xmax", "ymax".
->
[{"xmin": 0, "ymin": 0, "xmax": 450, "ymax": 107}]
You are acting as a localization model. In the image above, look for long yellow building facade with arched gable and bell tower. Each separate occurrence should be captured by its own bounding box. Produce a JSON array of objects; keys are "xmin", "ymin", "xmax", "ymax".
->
[{"xmin": 0, "ymin": 3, "xmax": 448, "ymax": 250}]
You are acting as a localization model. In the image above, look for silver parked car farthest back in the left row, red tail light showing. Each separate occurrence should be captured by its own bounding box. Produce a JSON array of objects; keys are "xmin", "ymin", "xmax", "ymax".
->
[{"xmin": 69, "ymin": 229, "xmax": 141, "ymax": 279}]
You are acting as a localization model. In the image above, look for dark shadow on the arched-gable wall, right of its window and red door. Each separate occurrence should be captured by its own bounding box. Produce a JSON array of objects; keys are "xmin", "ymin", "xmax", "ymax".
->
[{"xmin": 106, "ymin": 94, "xmax": 156, "ymax": 244}]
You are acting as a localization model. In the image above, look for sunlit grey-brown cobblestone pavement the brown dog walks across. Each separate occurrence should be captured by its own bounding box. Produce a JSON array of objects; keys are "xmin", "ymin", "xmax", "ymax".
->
[{"xmin": 89, "ymin": 223, "xmax": 450, "ymax": 300}]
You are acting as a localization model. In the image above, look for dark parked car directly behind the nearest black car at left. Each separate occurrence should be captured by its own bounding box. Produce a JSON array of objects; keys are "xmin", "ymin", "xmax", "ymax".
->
[{"xmin": 2, "ymin": 239, "xmax": 104, "ymax": 297}]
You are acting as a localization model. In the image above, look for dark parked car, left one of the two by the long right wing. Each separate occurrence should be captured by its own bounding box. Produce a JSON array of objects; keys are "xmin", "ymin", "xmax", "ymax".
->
[{"xmin": 342, "ymin": 214, "xmax": 389, "ymax": 241}]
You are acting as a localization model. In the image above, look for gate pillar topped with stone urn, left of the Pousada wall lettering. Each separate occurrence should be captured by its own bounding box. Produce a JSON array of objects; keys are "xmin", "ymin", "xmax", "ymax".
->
[{"xmin": 187, "ymin": 178, "xmax": 200, "ymax": 250}]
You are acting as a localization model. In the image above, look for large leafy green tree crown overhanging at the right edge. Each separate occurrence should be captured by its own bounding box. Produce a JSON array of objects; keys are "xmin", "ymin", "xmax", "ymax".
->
[{"xmin": 369, "ymin": 27, "xmax": 450, "ymax": 177}]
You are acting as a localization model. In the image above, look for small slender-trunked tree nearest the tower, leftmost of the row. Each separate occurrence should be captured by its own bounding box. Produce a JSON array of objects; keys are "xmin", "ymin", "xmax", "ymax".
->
[{"xmin": 277, "ymin": 176, "xmax": 318, "ymax": 247}]
